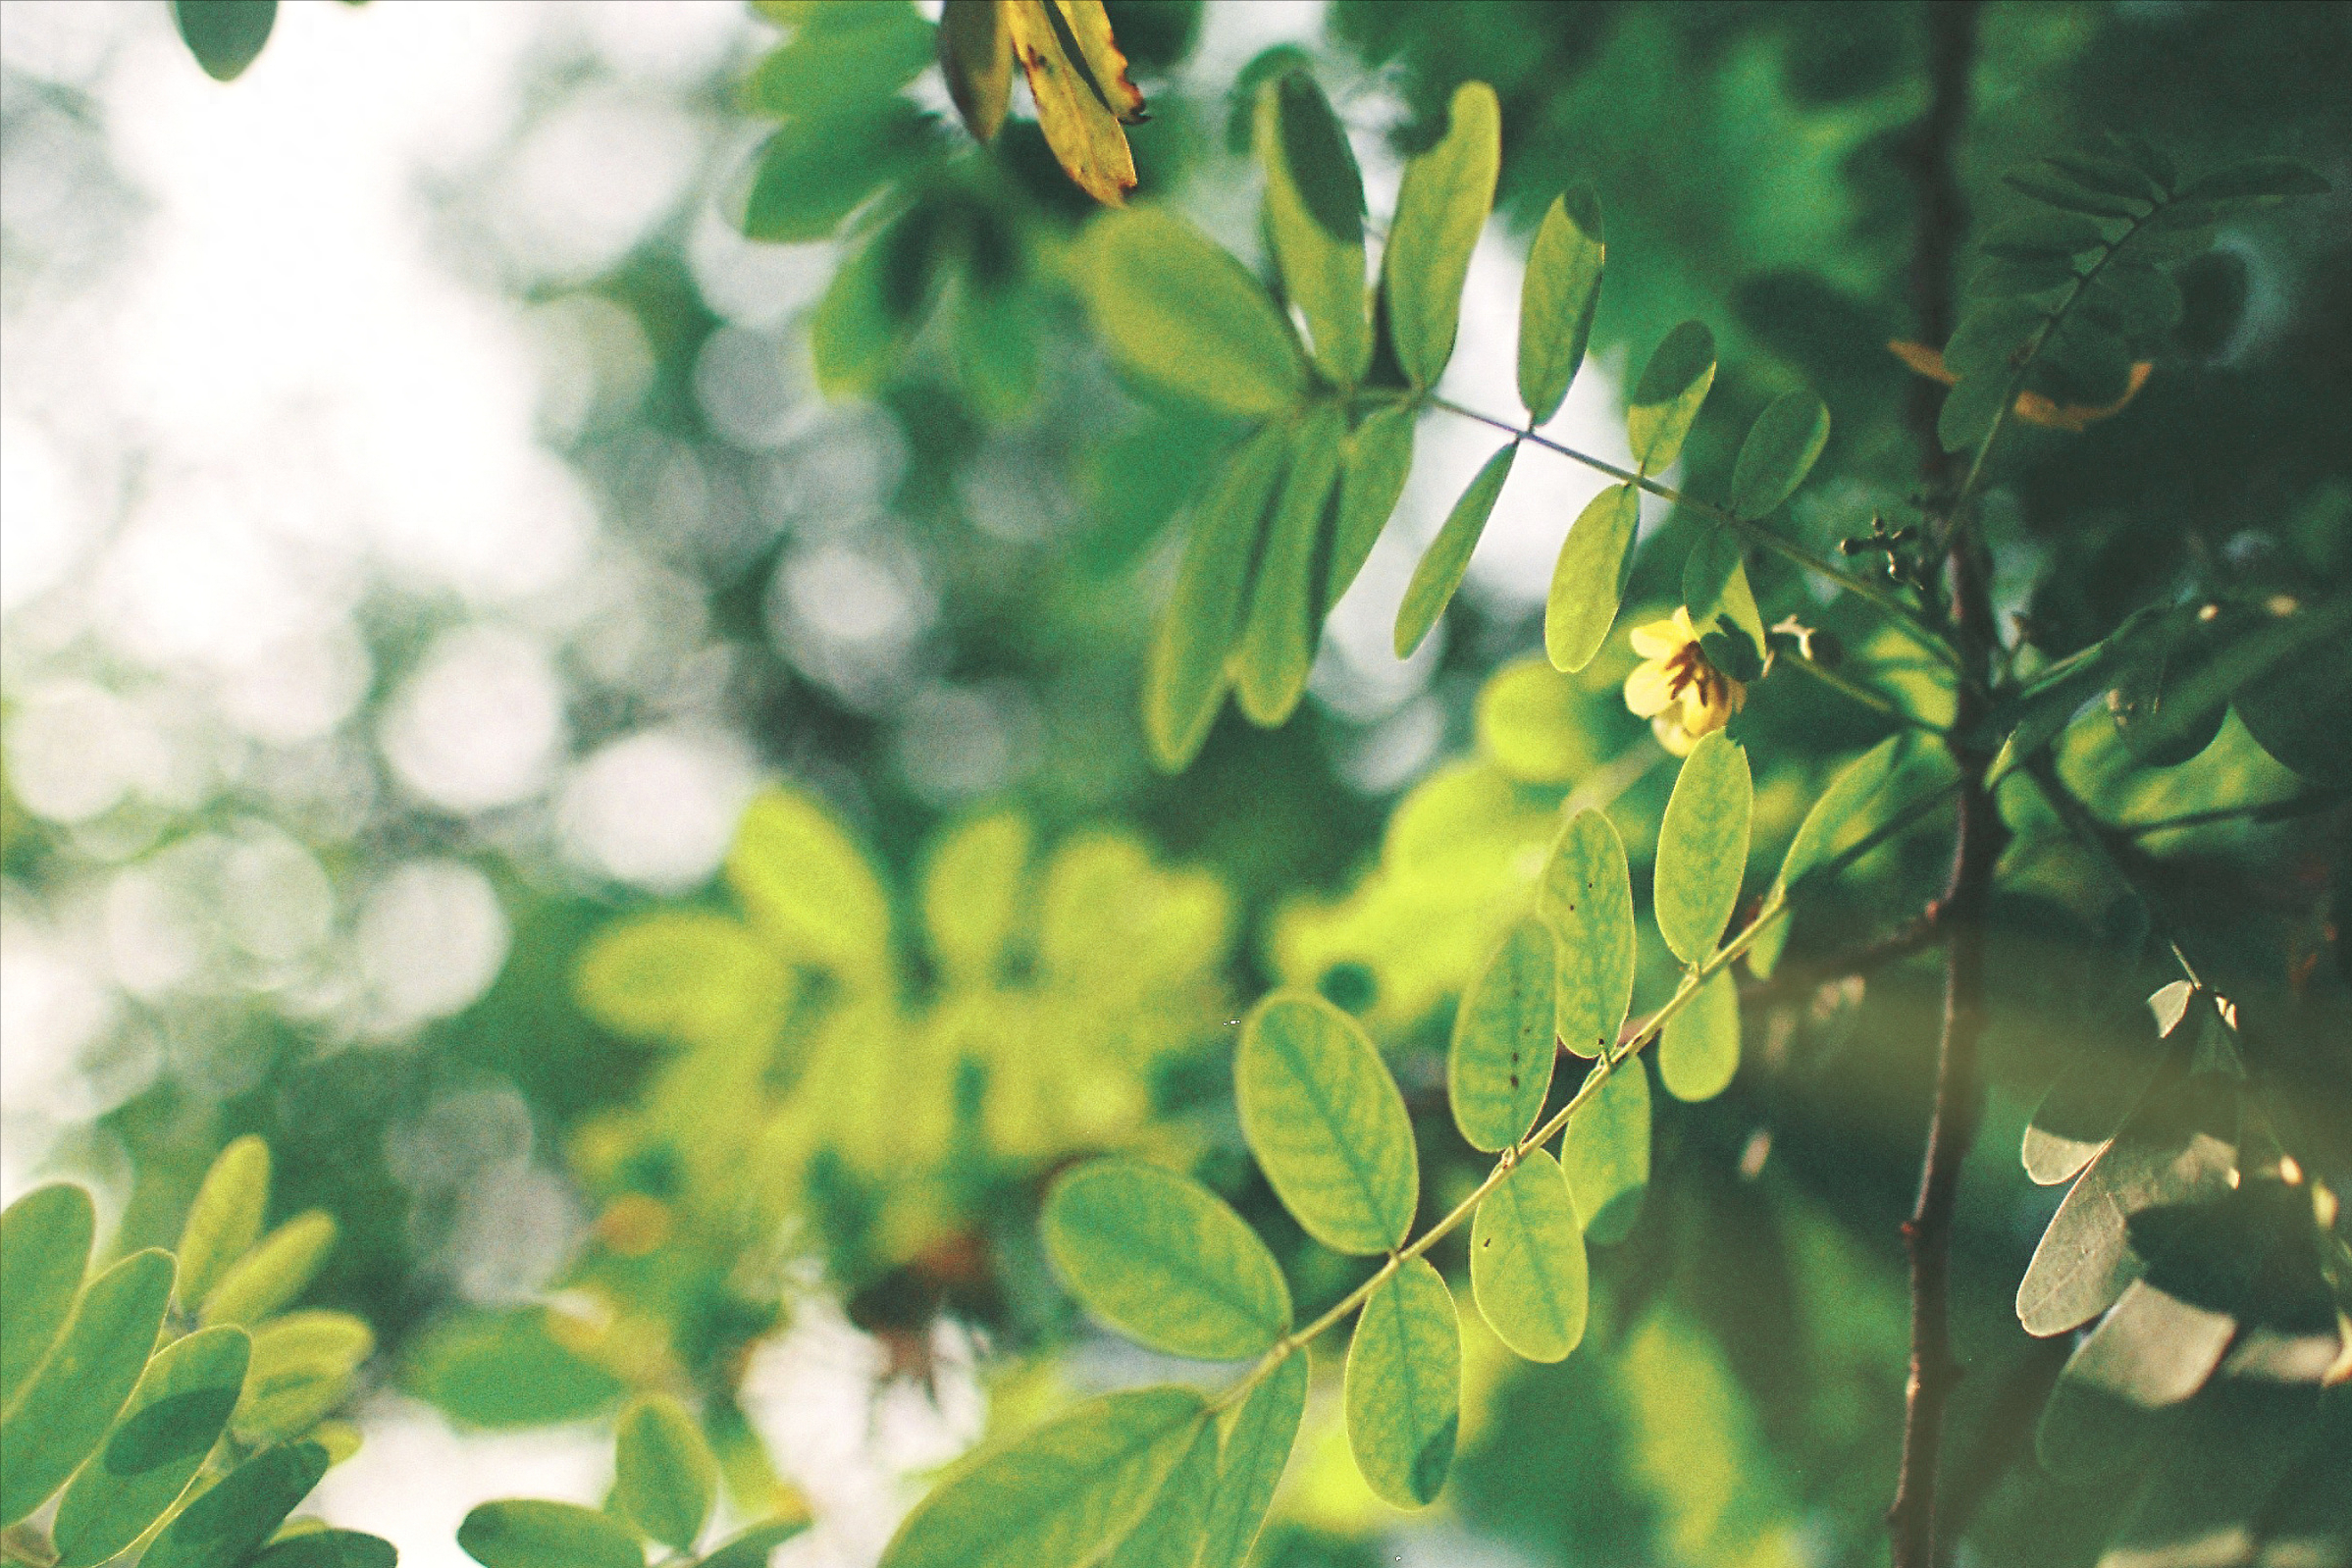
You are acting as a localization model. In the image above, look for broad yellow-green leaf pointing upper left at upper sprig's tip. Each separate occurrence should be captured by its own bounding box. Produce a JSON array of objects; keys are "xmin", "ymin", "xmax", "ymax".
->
[{"xmin": 1079, "ymin": 207, "xmax": 1305, "ymax": 416}]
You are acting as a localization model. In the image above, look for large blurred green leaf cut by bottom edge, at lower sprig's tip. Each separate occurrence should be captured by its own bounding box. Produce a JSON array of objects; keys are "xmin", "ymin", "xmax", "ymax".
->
[{"xmin": 879, "ymin": 1387, "xmax": 1209, "ymax": 1568}]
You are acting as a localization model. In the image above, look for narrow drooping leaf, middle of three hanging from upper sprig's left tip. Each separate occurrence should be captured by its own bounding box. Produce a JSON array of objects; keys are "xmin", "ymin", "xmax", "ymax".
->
[{"xmin": 1232, "ymin": 402, "xmax": 1347, "ymax": 726}]
